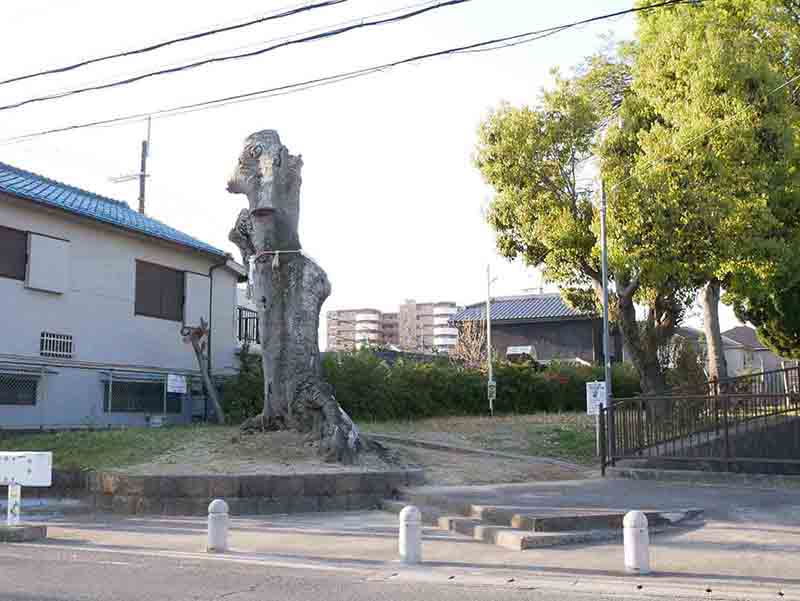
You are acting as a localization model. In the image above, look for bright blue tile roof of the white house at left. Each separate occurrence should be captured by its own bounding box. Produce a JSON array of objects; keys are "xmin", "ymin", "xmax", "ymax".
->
[{"xmin": 0, "ymin": 162, "xmax": 226, "ymax": 256}]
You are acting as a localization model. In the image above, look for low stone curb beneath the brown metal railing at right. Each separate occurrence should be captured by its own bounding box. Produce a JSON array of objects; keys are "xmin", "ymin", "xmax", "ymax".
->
[{"xmin": 606, "ymin": 467, "xmax": 800, "ymax": 489}]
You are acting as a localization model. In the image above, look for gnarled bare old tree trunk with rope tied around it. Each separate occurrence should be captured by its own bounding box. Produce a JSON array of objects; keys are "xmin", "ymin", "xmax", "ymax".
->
[{"xmin": 228, "ymin": 130, "xmax": 365, "ymax": 463}]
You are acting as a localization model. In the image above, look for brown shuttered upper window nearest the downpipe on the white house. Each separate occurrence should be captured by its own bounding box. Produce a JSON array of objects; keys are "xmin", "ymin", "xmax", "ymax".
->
[{"xmin": 134, "ymin": 261, "xmax": 184, "ymax": 321}]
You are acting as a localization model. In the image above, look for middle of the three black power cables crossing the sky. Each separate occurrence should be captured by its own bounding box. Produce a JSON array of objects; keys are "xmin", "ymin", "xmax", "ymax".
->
[{"xmin": 0, "ymin": 0, "xmax": 471, "ymax": 111}]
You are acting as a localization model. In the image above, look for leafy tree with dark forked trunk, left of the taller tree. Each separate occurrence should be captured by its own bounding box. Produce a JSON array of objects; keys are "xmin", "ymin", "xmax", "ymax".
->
[{"xmin": 476, "ymin": 57, "xmax": 691, "ymax": 392}]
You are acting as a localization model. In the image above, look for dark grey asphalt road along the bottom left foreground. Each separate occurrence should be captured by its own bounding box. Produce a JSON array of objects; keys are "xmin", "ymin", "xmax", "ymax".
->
[{"xmin": 0, "ymin": 546, "xmax": 656, "ymax": 601}]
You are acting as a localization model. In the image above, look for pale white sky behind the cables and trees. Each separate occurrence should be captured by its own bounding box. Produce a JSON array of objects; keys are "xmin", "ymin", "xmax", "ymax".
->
[{"xmin": 0, "ymin": 0, "xmax": 737, "ymax": 340}]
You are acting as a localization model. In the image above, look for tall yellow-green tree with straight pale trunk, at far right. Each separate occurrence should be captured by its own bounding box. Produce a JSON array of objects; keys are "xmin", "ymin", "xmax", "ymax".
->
[{"xmin": 620, "ymin": 0, "xmax": 800, "ymax": 377}]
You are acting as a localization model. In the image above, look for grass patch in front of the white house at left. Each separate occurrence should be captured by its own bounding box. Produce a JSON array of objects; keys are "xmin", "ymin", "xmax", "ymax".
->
[{"xmin": 0, "ymin": 426, "xmax": 209, "ymax": 469}]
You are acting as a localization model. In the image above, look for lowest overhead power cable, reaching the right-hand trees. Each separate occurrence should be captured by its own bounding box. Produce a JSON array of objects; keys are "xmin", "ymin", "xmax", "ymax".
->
[{"xmin": 0, "ymin": 0, "xmax": 692, "ymax": 145}]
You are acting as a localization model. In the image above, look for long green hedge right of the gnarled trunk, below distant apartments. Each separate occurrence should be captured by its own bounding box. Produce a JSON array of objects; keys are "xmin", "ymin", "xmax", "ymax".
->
[{"xmin": 323, "ymin": 350, "xmax": 639, "ymax": 421}]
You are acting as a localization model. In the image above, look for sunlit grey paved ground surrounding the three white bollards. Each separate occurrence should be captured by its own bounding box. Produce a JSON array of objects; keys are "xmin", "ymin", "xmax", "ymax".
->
[{"xmin": 0, "ymin": 481, "xmax": 800, "ymax": 600}]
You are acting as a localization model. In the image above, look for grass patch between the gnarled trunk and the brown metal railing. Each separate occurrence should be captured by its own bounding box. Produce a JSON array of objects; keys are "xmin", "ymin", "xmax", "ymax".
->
[{"xmin": 362, "ymin": 413, "xmax": 596, "ymax": 465}]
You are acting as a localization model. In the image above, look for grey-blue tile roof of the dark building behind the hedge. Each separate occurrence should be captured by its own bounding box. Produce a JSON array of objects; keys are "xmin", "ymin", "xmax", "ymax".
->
[{"xmin": 451, "ymin": 294, "xmax": 594, "ymax": 322}]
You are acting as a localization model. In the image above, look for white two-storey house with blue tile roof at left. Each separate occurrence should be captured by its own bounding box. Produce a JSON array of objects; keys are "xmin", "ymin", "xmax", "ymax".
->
[{"xmin": 0, "ymin": 163, "xmax": 246, "ymax": 428}]
